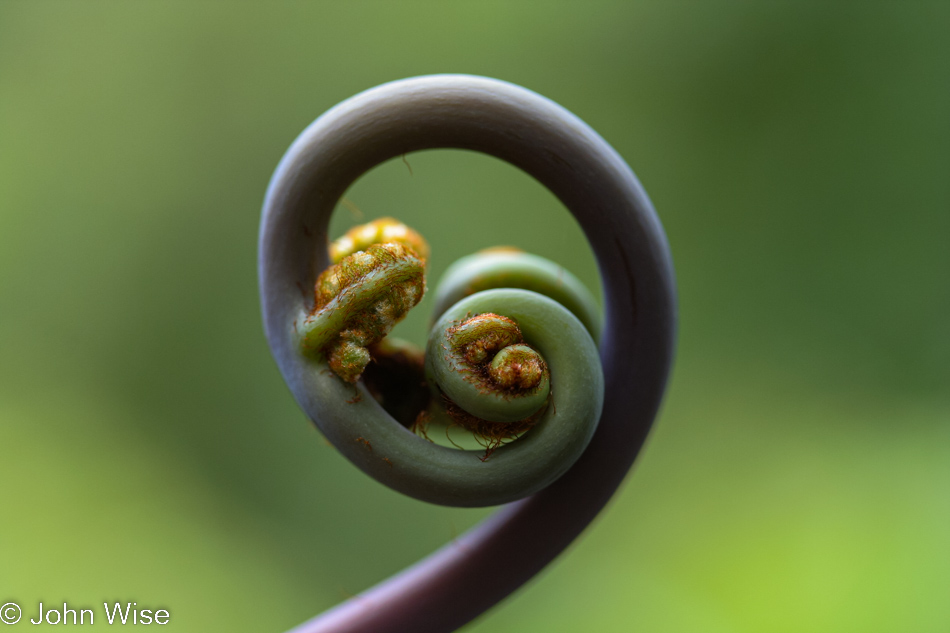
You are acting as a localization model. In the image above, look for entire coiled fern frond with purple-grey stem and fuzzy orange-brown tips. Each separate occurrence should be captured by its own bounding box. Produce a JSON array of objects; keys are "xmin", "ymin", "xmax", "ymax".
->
[{"xmin": 259, "ymin": 75, "xmax": 676, "ymax": 633}]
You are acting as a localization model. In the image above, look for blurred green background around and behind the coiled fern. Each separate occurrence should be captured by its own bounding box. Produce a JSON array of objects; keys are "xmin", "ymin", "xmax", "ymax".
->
[{"xmin": 0, "ymin": 0, "xmax": 950, "ymax": 633}]
